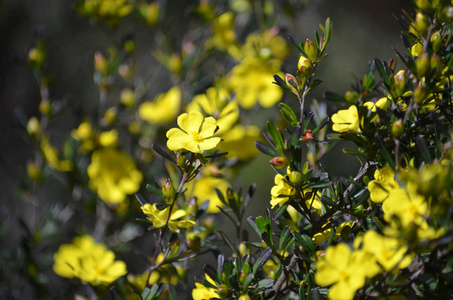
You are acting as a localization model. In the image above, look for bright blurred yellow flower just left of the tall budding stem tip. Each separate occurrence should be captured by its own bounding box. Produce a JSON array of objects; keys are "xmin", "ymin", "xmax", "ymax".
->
[{"xmin": 229, "ymin": 57, "xmax": 283, "ymax": 109}]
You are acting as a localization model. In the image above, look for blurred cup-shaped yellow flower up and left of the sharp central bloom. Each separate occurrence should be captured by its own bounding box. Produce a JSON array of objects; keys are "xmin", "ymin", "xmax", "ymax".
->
[{"xmin": 138, "ymin": 86, "xmax": 181, "ymax": 125}]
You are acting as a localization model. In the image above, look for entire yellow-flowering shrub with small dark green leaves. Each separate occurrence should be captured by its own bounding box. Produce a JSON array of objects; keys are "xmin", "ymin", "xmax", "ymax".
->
[{"xmin": 5, "ymin": 0, "xmax": 453, "ymax": 300}]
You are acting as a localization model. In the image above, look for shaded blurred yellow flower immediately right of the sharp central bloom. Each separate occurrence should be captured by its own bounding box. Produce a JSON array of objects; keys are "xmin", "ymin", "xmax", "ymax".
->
[{"xmin": 219, "ymin": 124, "xmax": 261, "ymax": 161}]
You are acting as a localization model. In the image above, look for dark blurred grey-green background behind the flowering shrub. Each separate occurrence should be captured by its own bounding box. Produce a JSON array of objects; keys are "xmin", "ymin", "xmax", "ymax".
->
[{"xmin": 0, "ymin": 0, "xmax": 410, "ymax": 299}]
